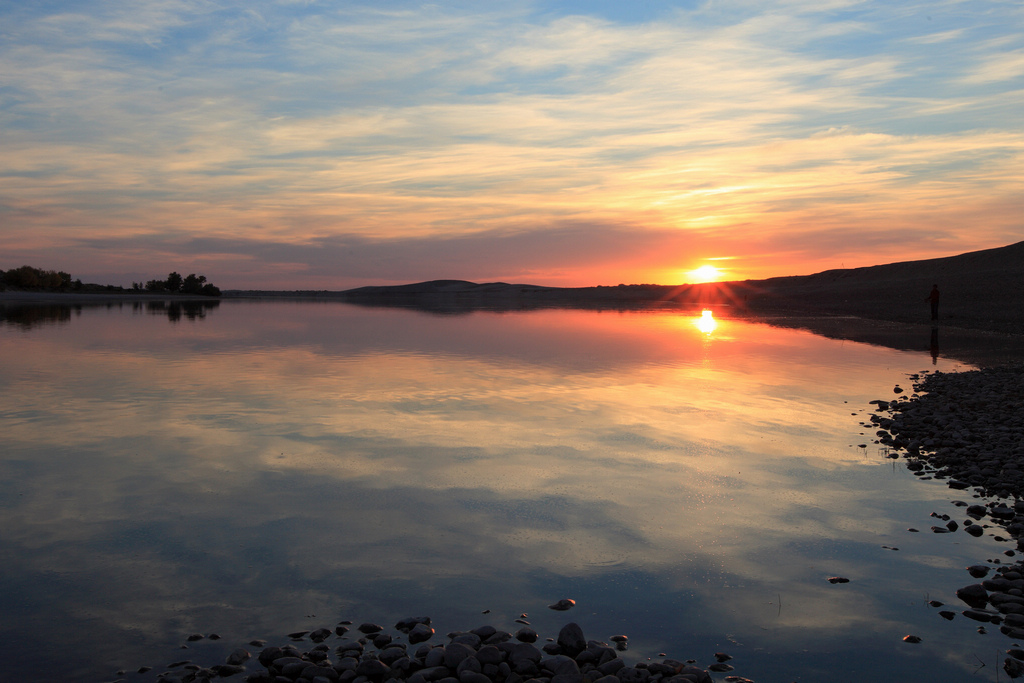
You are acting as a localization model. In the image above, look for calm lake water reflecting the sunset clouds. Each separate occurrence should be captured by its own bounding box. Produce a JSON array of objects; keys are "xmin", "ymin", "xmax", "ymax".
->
[{"xmin": 0, "ymin": 301, "xmax": 1010, "ymax": 683}]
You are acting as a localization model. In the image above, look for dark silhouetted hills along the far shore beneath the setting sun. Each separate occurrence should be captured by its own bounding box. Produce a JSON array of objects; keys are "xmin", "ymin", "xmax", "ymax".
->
[{"xmin": 224, "ymin": 242, "xmax": 1024, "ymax": 334}]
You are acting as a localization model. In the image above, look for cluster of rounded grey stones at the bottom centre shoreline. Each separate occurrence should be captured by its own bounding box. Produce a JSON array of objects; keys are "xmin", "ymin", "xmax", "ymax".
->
[{"xmin": 125, "ymin": 618, "xmax": 729, "ymax": 683}]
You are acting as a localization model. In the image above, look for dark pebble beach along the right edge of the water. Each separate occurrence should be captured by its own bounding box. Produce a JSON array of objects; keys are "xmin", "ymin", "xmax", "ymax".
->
[{"xmin": 871, "ymin": 365, "xmax": 1024, "ymax": 678}]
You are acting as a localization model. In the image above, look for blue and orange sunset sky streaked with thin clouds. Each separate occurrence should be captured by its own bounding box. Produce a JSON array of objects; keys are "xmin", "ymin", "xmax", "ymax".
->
[{"xmin": 0, "ymin": 0, "xmax": 1024, "ymax": 289}]
